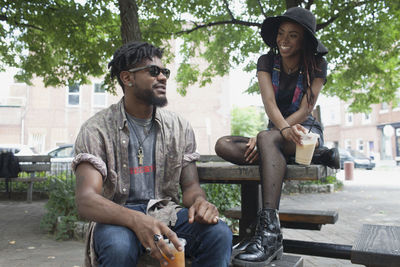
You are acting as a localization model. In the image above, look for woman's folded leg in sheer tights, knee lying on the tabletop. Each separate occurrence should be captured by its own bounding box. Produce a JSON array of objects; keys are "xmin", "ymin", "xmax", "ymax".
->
[{"xmin": 215, "ymin": 136, "xmax": 258, "ymax": 165}]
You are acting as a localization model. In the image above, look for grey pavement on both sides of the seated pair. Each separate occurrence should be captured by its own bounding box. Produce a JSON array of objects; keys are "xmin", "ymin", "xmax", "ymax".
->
[{"xmin": 0, "ymin": 166, "xmax": 400, "ymax": 267}]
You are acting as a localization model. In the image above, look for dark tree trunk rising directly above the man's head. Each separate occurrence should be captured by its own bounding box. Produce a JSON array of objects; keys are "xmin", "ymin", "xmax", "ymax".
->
[{"xmin": 118, "ymin": 0, "xmax": 142, "ymax": 44}]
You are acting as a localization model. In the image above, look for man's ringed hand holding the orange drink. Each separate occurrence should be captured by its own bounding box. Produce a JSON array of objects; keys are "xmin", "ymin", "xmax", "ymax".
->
[{"xmin": 132, "ymin": 214, "xmax": 183, "ymax": 265}]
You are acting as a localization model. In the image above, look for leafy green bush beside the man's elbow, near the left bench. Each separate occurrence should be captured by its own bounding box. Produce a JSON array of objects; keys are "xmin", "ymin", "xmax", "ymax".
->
[{"xmin": 40, "ymin": 175, "xmax": 78, "ymax": 240}]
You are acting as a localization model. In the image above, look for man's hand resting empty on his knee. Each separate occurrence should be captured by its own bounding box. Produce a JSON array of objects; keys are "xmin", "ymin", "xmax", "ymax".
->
[{"xmin": 189, "ymin": 196, "xmax": 219, "ymax": 224}]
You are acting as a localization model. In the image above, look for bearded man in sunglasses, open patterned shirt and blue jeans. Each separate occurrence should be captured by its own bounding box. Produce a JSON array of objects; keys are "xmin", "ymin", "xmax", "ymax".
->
[{"xmin": 72, "ymin": 42, "xmax": 232, "ymax": 267}]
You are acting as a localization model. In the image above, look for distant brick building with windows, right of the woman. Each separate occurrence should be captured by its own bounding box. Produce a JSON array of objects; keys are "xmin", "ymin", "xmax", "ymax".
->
[{"xmin": 321, "ymin": 95, "xmax": 400, "ymax": 164}]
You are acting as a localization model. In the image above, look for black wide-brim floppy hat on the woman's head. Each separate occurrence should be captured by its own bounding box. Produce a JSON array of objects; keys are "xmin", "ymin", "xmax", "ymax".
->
[{"xmin": 261, "ymin": 7, "xmax": 328, "ymax": 55}]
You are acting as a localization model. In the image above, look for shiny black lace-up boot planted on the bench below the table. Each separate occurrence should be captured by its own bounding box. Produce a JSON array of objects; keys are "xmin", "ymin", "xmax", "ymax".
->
[{"xmin": 232, "ymin": 209, "xmax": 283, "ymax": 267}]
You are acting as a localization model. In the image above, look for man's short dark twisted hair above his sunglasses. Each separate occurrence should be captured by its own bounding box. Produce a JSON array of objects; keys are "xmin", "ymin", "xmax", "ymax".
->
[{"xmin": 108, "ymin": 42, "xmax": 163, "ymax": 92}]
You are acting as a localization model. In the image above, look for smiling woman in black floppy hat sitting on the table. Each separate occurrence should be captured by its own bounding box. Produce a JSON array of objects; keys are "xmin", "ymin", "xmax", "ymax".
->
[{"xmin": 215, "ymin": 7, "xmax": 339, "ymax": 266}]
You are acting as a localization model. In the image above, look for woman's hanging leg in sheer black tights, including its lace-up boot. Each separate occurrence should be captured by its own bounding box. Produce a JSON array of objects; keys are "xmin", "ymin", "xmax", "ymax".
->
[{"xmin": 233, "ymin": 130, "xmax": 295, "ymax": 267}]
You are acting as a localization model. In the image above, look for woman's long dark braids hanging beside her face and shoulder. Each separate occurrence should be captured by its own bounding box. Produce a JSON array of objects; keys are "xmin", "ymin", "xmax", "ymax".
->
[{"xmin": 302, "ymin": 31, "xmax": 322, "ymax": 108}]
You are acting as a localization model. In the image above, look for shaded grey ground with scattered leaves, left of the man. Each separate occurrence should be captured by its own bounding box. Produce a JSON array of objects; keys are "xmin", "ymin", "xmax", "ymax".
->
[{"xmin": 0, "ymin": 200, "xmax": 84, "ymax": 267}]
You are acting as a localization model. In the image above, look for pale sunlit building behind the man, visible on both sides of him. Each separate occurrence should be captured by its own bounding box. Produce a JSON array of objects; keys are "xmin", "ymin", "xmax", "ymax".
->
[{"xmin": 0, "ymin": 45, "xmax": 230, "ymax": 154}]
